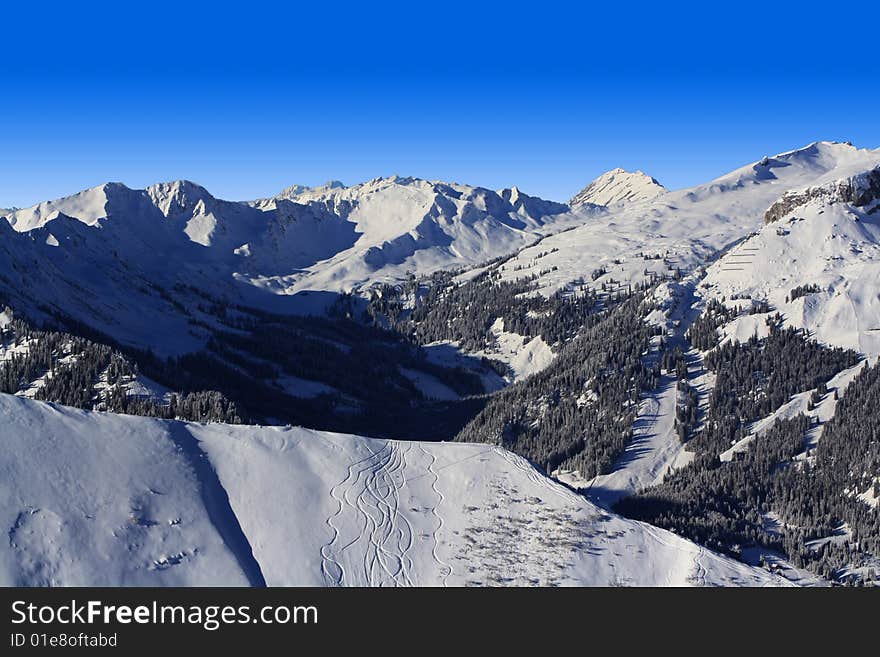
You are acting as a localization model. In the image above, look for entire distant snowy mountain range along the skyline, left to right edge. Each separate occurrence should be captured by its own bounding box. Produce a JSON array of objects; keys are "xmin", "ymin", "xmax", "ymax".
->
[{"xmin": 10, "ymin": 142, "xmax": 868, "ymax": 353}]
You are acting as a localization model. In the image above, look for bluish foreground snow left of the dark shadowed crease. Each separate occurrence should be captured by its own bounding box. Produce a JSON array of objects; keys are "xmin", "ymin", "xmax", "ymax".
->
[{"xmin": 0, "ymin": 395, "xmax": 248, "ymax": 586}]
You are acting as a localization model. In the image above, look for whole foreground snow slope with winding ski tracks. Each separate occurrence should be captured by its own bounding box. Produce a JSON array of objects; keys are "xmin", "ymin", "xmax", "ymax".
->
[{"xmin": 0, "ymin": 395, "xmax": 785, "ymax": 585}]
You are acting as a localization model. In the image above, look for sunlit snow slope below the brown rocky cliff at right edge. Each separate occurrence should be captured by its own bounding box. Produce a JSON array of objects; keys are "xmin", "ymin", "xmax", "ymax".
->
[{"xmin": 701, "ymin": 164, "xmax": 880, "ymax": 357}]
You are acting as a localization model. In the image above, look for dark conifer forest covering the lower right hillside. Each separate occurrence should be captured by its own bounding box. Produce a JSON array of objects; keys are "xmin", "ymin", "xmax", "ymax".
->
[{"xmin": 616, "ymin": 307, "xmax": 880, "ymax": 582}]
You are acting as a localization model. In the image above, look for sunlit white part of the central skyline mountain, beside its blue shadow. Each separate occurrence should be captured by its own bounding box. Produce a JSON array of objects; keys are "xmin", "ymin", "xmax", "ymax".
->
[{"xmin": 255, "ymin": 176, "xmax": 584, "ymax": 294}]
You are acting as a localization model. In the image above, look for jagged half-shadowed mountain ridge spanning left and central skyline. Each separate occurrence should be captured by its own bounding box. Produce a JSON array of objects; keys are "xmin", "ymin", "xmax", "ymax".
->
[{"xmin": 6, "ymin": 176, "xmax": 582, "ymax": 294}]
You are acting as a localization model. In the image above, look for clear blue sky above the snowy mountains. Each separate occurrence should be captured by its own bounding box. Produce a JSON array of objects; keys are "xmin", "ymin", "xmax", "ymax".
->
[{"xmin": 0, "ymin": 0, "xmax": 880, "ymax": 207}]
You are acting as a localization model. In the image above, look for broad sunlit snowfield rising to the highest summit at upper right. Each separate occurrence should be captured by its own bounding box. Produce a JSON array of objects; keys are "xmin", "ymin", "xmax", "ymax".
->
[{"xmin": 502, "ymin": 142, "xmax": 880, "ymax": 294}]
